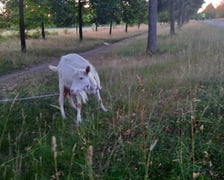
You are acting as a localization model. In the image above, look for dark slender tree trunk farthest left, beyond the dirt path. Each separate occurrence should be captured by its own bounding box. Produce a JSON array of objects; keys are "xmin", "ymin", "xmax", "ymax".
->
[{"xmin": 19, "ymin": 0, "xmax": 26, "ymax": 52}]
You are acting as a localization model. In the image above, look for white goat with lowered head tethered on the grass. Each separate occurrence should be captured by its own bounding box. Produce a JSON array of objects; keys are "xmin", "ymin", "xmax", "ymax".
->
[{"xmin": 49, "ymin": 54, "xmax": 107, "ymax": 123}]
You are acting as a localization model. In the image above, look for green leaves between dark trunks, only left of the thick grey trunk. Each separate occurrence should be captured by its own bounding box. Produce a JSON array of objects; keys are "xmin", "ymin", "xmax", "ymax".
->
[{"xmin": 1, "ymin": 0, "xmax": 149, "ymax": 29}]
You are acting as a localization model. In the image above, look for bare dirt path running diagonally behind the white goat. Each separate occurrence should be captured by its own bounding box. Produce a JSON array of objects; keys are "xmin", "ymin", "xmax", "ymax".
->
[{"xmin": 0, "ymin": 34, "xmax": 147, "ymax": 94}]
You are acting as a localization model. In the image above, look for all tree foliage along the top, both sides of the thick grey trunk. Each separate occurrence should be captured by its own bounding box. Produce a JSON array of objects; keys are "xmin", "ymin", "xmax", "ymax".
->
[{"xmin": 0, "ymin": 0, "xmax": 203, "ymax": 29}]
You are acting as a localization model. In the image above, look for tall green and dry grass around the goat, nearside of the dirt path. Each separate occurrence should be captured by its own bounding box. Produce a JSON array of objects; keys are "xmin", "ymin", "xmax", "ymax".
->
[{"xmin": 0, "ymin": 22, "xmax": 224, "ymax": 179}]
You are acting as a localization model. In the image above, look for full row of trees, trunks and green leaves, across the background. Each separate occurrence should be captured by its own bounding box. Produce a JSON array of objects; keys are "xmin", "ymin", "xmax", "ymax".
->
[{"xmin": 0, "ymin": 0, "xmax": 203, "ymax": 52}]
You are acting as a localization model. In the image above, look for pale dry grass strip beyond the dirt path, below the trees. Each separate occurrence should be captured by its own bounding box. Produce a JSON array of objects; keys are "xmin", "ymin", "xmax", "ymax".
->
[{"xmin": 0, "ymin": 26, "xmax": 147, "ymax": 75}]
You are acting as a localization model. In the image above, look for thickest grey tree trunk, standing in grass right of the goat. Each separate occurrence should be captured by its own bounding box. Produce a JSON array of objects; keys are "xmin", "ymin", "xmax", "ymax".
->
[{"xmin": 146, "ymin": 0, "xmax": 158, "ymax": 54}]
